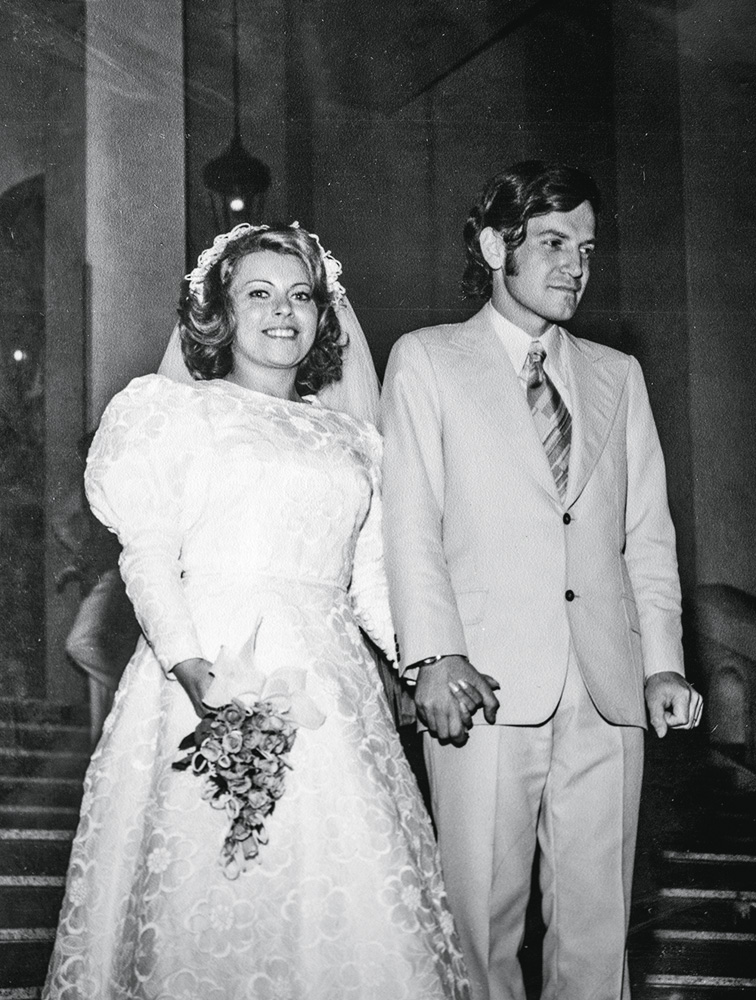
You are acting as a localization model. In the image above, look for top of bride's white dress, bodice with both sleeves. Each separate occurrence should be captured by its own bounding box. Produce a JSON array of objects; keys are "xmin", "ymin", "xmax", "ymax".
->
[{"xmin": 86, "ymin": 375, "xmax": 392, "ymax": 669}]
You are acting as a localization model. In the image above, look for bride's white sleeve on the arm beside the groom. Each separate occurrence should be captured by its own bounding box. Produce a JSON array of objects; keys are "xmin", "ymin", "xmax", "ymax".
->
[{"xmin": 350, "ymin": 424, "xmax": 396, "ymax": 661}]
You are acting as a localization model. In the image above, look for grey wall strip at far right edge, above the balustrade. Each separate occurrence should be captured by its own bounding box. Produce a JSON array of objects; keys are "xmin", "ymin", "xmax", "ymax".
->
[{"xmin": 676, "ymin": 0, "xmax": 756, "ymax": 594}]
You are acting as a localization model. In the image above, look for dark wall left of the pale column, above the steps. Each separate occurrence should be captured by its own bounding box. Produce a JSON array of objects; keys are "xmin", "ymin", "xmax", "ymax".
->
[{"xmin": 0, "ymin": 0, "xmax": 86, "ymax": 699}]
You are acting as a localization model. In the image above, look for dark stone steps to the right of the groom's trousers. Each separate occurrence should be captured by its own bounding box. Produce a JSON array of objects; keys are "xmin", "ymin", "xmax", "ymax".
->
[{"xmin": 630, "ymin": 734, "xmax": 756, "ymax": 1000}]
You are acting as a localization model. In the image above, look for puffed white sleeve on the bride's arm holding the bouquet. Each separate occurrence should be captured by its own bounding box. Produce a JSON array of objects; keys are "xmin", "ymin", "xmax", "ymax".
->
[{"xmin": 84, "ymin": 375, "xmax": 210, "ymax": 678}]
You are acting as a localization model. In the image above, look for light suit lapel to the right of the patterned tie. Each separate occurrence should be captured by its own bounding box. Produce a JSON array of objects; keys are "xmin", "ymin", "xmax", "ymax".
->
[{"xmin": 562, "ymin": 330, "xmax": 628, "ymax": 507}]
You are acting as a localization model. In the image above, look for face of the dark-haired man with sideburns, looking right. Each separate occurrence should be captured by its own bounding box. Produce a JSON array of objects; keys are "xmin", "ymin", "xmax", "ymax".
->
[{"xmin": 493, "ymin": 201, "xmax": 596, "ymax": 336}]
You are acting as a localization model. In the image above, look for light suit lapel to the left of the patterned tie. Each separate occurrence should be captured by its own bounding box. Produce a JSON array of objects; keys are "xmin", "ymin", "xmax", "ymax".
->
[{"xmin": 448, "ymin": 312, "xmax": 559, "ymax": 503}]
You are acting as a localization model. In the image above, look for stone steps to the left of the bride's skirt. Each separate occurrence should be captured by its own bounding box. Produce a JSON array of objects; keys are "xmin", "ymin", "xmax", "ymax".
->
[{"xmin": 0, "ymin": 699, "xmax": 90, "ymax": 1000}]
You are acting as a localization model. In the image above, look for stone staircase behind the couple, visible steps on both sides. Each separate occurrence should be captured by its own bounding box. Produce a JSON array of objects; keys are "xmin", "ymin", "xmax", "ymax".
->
[{"xmin": 0, "ymin": 699, "xmax": 756, "ymax": 1000}]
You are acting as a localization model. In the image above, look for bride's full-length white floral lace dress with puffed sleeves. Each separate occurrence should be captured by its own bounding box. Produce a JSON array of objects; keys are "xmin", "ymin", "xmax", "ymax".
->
[{"xmin": 43, "ymin": 375, "xmax": 468, "ymax": 1000}]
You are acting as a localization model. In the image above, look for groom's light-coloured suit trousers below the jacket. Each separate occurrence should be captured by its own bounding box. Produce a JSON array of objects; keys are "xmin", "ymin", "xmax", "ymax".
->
[{"xmin": 424, "ymin": 653, "xmax": 643, "ymax": 1000}]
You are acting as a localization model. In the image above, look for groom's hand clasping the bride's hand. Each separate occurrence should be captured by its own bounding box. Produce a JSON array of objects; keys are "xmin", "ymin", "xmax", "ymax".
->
[{"xmin": 415, "ymin": 656, "xmax": 499, "ymax": 746}]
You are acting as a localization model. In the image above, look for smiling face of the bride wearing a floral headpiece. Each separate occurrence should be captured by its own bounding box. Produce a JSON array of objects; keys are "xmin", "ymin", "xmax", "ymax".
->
[{"xmin": 229, "ymin": 250, "xmax": 318, "ymax": 369}]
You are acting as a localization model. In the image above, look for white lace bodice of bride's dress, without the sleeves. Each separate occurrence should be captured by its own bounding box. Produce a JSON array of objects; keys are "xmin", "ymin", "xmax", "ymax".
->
[{"xmin": 175, "ymin": 381, "xmax": 376, "ymax": 589}]
